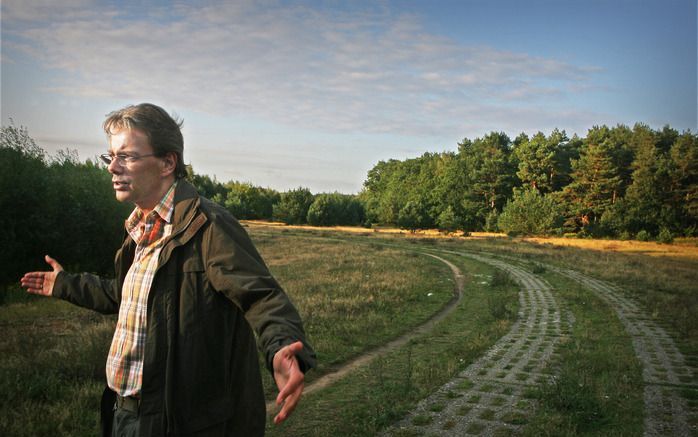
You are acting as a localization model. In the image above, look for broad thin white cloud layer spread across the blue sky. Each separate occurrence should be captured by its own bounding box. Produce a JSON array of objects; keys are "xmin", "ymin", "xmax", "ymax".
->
[{"xmin": 3, "ymin": 0, "xmax": 597, "ymax": 136}]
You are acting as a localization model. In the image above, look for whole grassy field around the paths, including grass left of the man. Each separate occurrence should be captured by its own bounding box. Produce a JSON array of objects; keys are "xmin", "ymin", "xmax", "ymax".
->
[{"xmin": 0, "ymin": 225, "xmax": 698, "ymax": 436}]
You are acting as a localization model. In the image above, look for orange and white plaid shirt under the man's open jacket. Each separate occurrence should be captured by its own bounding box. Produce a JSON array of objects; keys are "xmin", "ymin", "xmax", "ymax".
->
[{"xmin": 107, "ymin": 182, "xmax": 177, "ymax": 396}]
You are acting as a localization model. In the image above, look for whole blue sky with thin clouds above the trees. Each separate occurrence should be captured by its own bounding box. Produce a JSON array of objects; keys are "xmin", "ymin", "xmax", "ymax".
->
[{"xmin": 0, "ymin": 0, "xmax": 698, "ymax": 193}]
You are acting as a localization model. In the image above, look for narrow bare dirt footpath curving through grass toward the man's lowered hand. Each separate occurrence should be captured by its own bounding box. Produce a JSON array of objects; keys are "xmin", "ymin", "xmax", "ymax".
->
[{"xmin": 267, "ymin": 252, "xmax": 464, "ymax": 413}]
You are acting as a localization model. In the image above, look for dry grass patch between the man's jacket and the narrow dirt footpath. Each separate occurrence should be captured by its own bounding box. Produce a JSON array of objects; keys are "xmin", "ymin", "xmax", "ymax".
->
[{"xmin": 250, "ymin": 228, "xmax": 454, "ymax": 373}]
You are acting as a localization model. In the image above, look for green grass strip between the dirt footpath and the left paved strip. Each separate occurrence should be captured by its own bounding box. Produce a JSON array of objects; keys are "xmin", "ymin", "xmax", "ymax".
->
[{"xmin": 260, "ymin": 247, "xmax": 517, "ymax": 436}]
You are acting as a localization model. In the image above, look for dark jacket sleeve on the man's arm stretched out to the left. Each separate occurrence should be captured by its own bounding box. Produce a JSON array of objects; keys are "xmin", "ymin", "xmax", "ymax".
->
[{"xmin": 53, "ymin": 271, "xmax": 119, "ymax": 314}]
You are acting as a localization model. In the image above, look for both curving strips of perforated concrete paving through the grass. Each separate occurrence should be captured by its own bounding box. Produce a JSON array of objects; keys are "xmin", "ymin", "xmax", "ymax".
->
[{"xmin": 387, "ymin": 252, "xmax": 698, "ymax": 437}]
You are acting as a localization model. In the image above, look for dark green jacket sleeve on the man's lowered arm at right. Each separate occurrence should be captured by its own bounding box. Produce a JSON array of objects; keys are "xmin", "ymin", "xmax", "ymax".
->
[{"xmin": 204, "ymin": 209, "xmax": 316, "ymax": 372}]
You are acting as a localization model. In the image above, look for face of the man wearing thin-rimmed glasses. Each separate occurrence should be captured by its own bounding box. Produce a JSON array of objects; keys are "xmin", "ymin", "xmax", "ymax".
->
[{"xmin": 107, "ymin": 129, "xmax": 169, "ymax": 210}]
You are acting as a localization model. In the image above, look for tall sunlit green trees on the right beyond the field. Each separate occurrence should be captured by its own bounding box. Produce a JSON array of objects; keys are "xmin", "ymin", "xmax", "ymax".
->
[{"xmin": 359, "ymin": 123, "xmax": 698, "ymax": 240}]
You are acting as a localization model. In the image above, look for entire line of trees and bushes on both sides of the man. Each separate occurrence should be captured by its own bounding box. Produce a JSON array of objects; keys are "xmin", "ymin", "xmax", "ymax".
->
[{"xmin": 0, "ymin": 123, "xmax": 698, "ymax": 292}]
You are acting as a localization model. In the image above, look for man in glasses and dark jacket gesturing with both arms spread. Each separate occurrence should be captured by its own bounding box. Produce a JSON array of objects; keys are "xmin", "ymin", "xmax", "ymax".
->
[{"xmin": 21, "ymin": 103, "xmax": 315, "ymax": 436}]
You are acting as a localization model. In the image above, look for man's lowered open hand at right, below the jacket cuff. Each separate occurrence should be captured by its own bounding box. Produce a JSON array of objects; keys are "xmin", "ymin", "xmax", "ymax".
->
[{"xmin": 274, "ymin": 341, "xmax": 305, "ymax": 425}]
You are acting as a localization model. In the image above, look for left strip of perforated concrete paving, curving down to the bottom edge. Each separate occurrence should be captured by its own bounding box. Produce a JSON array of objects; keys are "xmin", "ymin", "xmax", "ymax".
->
[{"xmin": 386, "ymin": 251, "xmax": 573, "ymax": 436}]
